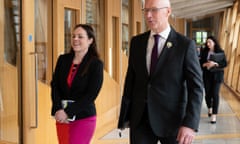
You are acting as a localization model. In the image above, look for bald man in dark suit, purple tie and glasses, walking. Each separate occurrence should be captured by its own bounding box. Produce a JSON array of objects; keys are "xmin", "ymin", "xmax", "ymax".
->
[{"xmin": 118, "ymin": 0, "xmax": 203, "ymax": 144}]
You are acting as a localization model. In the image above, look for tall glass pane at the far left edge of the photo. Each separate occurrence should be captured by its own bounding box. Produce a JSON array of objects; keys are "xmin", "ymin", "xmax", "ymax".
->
[{"xmin": 0, "ymin": 0, "xmax": 22, "ymax": 144}]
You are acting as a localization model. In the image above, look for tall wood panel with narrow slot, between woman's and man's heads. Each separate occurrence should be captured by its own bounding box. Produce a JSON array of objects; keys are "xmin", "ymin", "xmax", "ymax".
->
[{"xmin": 104, "ymin": 0, "xmax": 121, "ymax": 82}]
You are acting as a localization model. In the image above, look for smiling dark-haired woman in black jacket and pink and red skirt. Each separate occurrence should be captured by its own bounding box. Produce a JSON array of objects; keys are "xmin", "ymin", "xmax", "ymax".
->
[{"xmin": 51, "ymin": 24, "xmax": 103, "ymax": 144}]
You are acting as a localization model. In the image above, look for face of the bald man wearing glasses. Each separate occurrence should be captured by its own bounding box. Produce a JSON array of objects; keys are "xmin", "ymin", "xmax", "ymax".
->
[{"xmin": 143, "ymin": 0, "xmax": 171, "ymax": 32}]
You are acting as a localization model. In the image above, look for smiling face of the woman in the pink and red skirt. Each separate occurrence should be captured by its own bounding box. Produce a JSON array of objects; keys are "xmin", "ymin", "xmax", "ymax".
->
[{"xmin": 71, "ymin": 27, "xmax": 93, "ymax": 52}]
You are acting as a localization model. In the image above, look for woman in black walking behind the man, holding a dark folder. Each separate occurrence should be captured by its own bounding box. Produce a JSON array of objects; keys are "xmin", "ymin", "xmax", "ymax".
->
[{"xmin": 200, "ymin": 36, "xmax": 227, "ymax": 124}]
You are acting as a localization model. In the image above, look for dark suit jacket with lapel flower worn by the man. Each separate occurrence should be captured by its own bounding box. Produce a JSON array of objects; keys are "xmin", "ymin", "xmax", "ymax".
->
[{"xmin": 118, "ymin": 28, "xmax": 203, "ymax": 137}]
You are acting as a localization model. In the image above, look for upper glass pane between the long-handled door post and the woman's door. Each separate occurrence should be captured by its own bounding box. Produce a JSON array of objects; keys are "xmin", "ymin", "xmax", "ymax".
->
[{"xmin": 35, "ymin": 0, "xmax": 52, "ymax": 82}]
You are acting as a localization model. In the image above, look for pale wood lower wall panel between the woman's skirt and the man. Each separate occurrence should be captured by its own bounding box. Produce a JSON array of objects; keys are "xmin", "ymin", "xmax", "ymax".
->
[{"xmin": 96, "ymin": 72, "xmax": 120, "ymax": 140}]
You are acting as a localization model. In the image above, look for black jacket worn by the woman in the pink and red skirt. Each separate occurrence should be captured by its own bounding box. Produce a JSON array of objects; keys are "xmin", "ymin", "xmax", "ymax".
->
[{"xmin": 51, "ymin": 53, "xmax": 103, "ymax": 119}]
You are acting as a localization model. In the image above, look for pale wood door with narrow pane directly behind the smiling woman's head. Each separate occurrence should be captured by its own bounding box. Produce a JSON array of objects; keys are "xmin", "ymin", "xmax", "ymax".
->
[{"xmin": 53, "ymin": 0, "xmax": 86, "ymax": 66}]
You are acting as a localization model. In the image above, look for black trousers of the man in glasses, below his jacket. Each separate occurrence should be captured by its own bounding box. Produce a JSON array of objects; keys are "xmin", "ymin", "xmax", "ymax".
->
[{"xmin": 130, "ymin": 106, "xmax": 178, "ymax": 144}]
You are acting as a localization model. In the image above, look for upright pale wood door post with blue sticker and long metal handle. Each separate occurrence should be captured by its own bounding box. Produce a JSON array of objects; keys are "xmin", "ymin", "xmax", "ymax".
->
[{"xmin": 22, "ymin": 0, "xmax": 37, "ymax": 144}]
